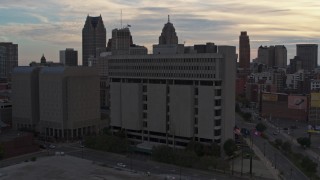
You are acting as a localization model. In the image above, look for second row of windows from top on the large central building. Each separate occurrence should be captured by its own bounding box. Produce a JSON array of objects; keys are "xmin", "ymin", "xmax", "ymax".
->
[{"xmin": 109, "ymin": 65, "xmax": 214, "ymax": 71}]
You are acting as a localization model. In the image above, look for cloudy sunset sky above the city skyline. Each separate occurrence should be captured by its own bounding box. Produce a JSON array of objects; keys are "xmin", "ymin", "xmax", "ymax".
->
[{"xmin": 0, "ymin": 0, "xmax": 320, "ymax": 65}]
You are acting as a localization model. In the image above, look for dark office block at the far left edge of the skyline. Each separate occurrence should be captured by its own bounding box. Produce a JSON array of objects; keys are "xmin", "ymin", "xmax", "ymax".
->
[{"xmin": 0, "ymin": 42, "xmax": 18, "ymax": 79}]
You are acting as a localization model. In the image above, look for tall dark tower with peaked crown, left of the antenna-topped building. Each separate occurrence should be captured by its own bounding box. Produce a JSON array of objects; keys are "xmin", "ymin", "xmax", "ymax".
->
[{"xmin": 82, "ymin": 15, "xmax": 107, "ymax": 66}]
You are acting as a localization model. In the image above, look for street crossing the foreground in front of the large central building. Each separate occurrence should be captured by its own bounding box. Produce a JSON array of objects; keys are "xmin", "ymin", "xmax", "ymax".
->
[{"xmin": 55, "ymin": 144, "xmax": 245, "ymax": 180}]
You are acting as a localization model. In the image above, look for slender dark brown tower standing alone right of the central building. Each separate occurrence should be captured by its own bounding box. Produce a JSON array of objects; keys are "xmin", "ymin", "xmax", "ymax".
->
[{"xmin": 239, "ymin": 31, "xmax": 250, "ymax": 69}]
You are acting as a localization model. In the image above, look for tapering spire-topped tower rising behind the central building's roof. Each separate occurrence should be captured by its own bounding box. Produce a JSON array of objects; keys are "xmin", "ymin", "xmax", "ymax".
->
[{"xmin": 159, "ymin": 15, "xmax": 178, "ymax": 44}]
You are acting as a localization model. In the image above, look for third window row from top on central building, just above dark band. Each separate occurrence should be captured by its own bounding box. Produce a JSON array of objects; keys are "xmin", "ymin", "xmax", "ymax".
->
[{"xmin": 109, "ymin": 72, "xmax": 216, "ymax": 78}]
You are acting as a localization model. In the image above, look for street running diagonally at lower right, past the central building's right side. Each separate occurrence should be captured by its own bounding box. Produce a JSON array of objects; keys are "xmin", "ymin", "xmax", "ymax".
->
[{"xmin": 236, "ymin": 113, "xmax": 309, "ymax": 180}]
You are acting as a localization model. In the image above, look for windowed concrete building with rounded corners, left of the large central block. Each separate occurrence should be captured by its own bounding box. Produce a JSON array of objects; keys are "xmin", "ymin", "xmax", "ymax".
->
[{"xmin": 12, "ymin": 67, "xmax": 103, "ymax": 139}]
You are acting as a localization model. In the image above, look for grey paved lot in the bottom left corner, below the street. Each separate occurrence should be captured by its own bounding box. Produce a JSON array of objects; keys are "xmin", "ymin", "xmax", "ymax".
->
[{"xmin": 0, "ymin": 155, "xmax": 163, "ymax": 180}]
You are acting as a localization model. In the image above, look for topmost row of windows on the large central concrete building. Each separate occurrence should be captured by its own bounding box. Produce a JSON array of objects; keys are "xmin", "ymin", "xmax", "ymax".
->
[{"xmin": 108, "ymin": 58, "xmax": 216, "ymax": 65}]
